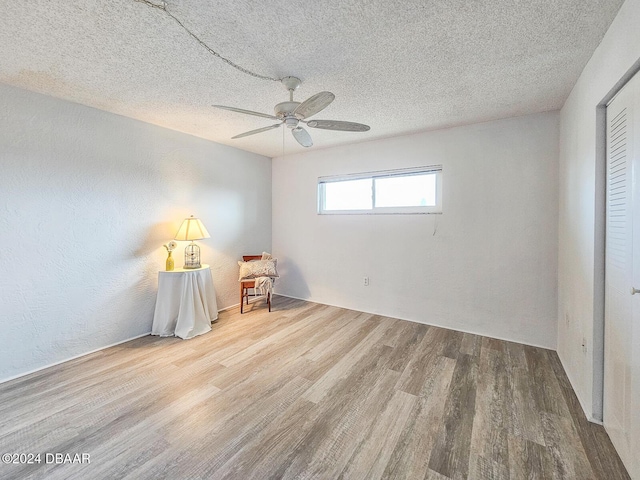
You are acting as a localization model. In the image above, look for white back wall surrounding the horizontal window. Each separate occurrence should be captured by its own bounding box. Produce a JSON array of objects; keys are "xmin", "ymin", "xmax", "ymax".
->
[{"xmin": 272, "ymin": 112, "xmax": 558, "ymax": 348}]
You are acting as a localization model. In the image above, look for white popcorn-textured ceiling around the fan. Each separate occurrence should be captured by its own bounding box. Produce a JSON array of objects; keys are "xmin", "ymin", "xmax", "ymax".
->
[{"xmin": 0, "ymin": 0, "xmax": 623, "ymax": 157}]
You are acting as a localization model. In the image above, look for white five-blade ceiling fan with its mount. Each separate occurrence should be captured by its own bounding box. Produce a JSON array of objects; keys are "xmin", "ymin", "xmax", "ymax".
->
[{"xmin": 213, "ymin": 77, "xmax": 371, "ymax": 147}]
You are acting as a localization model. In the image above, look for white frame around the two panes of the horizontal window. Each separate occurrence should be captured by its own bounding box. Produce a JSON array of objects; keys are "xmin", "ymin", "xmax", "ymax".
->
[{"xmin": 318, "ymin": 165, "xmax": 442, "ymax": 215}]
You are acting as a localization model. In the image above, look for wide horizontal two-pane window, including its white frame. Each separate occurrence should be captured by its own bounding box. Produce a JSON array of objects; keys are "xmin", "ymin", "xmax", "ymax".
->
[{"xmin": 318, "ymin": 165, "xmax": 442, "ymax": 214}]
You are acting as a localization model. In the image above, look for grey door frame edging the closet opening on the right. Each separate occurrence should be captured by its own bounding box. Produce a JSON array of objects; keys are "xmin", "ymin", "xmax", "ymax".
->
[{"xmin": 590, "ymin": 58, "xmax": 640, "ymax": 423}]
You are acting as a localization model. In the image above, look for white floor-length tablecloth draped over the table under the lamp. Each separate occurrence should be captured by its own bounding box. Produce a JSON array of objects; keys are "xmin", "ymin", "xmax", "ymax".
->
[{"xmin": 151, "ymin": 265, "xmax": 218, "ymax": 339}]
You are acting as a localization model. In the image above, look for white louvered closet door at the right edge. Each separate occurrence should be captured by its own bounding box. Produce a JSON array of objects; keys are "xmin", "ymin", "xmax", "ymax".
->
[{"xmin": 604, "ymin": 68, "xmax": 640, "ymax": 479}]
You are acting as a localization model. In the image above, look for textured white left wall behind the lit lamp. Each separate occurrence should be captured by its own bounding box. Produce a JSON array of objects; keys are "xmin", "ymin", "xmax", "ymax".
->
[{"xmin": 0, "ymin": 85, "xmax": 271, "ymax": 380}]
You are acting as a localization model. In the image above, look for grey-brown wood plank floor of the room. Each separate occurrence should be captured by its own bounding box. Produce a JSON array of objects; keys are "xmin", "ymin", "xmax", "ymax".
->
[{"xmin": 0, "ymin": 297, "xmax": 629, "ymax": 480}]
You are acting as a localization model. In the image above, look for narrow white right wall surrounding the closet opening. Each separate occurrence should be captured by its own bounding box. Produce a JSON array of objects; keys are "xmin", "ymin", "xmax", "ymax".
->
[{"xmin": 558, "ymin": 0, "xmax": 640, "ymax": 419}]
